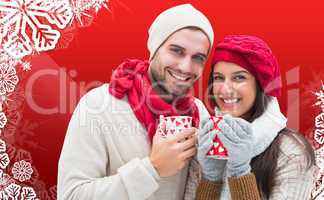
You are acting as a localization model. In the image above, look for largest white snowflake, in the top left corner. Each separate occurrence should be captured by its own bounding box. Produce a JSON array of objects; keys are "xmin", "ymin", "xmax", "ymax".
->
[{"xmin": 0, "ymin": 0, "xmax": 72, "ymax": 58}]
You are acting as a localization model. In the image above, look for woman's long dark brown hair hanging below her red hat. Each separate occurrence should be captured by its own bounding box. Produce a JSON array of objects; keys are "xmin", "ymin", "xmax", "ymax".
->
[{"xmin": 208, "ymin": 68, "xmax": 315, "ymax": 198}]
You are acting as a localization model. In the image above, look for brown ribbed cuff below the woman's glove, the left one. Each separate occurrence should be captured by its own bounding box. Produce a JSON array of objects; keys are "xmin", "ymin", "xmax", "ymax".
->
[{"xmin": 196, "ymin": 179, "xmax": 223, "ymax": 200}]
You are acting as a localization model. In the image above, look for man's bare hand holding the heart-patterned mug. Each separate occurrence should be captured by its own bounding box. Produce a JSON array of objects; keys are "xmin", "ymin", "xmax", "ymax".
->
[{"xmin": 150, "ymin": 127, "xmax": 197, "ymax": 177}]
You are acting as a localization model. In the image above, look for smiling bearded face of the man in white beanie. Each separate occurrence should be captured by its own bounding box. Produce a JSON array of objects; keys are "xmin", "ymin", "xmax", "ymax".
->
[{"xmin": 150, "ymin": 29, "xmax": 210, "ymax": 98}]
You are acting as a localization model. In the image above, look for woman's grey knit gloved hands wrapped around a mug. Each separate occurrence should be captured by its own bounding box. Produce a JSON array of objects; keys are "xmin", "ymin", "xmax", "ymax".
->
[{"xmin": 198, "ymin": 115, "xmax": 253, "ymax": 181}]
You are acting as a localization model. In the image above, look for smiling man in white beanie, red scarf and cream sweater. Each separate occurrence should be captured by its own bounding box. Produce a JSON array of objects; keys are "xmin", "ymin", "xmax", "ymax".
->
[{"xmin": 58, "ymin": 4, "xmax": 214, "ymax": 200}]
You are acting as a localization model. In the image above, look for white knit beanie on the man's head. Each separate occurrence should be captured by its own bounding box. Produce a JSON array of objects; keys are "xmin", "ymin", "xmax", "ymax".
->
[{"xmin": 147, "ymin": 4, "xmax": 214, "ymax": 60}]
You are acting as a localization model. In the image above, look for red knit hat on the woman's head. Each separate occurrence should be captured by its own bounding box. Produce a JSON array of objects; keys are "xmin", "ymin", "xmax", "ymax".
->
[{"xmin": 212, "ymin": 35, "xmax": 282, "ymax": 97}]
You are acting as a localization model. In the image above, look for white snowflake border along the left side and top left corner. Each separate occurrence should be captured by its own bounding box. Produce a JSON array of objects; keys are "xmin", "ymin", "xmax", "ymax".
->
[{"xmin": 0, "ymin": 0, "xmax": 109, "ymax": 200}]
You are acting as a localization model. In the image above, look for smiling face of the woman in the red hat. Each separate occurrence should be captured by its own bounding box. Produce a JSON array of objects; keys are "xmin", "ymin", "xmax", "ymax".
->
[{"xmin": 213, "ymin": 61, "xmax": 257, "ymax": 118}]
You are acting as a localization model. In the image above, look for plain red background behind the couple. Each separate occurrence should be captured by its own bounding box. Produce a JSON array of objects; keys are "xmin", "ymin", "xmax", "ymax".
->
[{"xmin": 20, "ymin": 0, "xmax": 324, "ymax": 186}]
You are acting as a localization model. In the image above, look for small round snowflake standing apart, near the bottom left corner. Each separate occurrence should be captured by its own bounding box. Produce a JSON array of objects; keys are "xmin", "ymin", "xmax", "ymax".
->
[{"xmin": 12, "ymin": 160, "xmax": 33, "ymax": 182}]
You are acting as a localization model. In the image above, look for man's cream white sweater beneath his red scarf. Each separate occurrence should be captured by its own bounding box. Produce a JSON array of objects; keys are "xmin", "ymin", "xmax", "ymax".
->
[{"xmin": 58, "ymin": 84, "xmax": 209, "ymax": 200}]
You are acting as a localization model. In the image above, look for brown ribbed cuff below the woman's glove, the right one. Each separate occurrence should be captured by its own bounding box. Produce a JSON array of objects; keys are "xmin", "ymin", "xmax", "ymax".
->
[{"xmin": 228, "ymin": 173, "xmax": 260, "ymax": 200}]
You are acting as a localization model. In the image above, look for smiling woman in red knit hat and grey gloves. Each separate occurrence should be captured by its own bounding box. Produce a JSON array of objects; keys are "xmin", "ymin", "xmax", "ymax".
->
[{"xmin": 188, "ymin": 35, "xmax": 315, "ymax": 200}]
